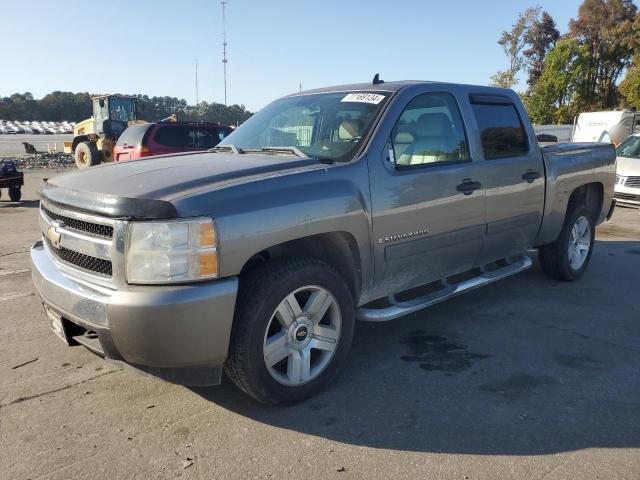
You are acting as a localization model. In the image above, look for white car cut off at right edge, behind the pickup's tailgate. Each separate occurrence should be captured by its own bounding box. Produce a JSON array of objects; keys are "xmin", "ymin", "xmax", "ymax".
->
[{"xmin": 613, "ymin": 133, "xmax": 640, "ymax": 207}]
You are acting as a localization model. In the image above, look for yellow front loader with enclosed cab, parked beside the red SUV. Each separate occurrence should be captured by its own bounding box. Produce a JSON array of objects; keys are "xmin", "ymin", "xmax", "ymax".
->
[{"xmin": 64, "ymin": 95, "xmax": 145, "ymax": 168}]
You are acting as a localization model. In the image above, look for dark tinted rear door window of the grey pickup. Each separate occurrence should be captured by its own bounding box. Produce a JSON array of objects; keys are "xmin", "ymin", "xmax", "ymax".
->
[{"xmin": 472, "ymin": 103, "xmax": 527, "ymax": 160}]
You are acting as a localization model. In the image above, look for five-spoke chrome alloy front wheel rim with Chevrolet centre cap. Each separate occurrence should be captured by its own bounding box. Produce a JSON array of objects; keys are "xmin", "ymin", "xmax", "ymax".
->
[{"xmin": 262, "ymin": 285, "xmax": 342, "ymax": 386}]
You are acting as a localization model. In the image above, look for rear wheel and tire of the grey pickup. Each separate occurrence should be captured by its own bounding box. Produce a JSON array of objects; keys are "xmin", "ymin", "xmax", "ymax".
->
[{"xmin": 538, "ymin": 205, "xmax": 595, "ymax": 281}]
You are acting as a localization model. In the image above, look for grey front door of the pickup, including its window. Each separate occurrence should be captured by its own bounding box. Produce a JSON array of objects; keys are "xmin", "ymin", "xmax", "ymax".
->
[{"xmin": 370, "ymin": 89, "xmax": 485, "ymax": 293}]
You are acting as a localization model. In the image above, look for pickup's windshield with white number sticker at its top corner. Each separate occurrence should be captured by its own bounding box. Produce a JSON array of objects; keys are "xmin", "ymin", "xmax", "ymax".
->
[{"xmin": 220, "ymin": 92, "xmax": 389, "ymax": 161}]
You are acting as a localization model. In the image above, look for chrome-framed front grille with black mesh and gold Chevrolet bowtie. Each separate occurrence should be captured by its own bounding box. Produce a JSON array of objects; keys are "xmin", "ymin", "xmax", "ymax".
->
[{"xmin": 40, "ymin": 200, "xmax": 128, "ymax": 288}]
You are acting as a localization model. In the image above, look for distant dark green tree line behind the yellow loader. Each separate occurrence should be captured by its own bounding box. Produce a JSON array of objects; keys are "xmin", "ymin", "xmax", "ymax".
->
[{"xmin": 0, "ymin": 92, "xmax": 253, "ymax": 125}]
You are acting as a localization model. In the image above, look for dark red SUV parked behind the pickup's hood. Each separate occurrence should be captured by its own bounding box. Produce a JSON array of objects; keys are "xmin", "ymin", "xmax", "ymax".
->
[{"xmin": 113, "ymin": 122, "xmax": 233, "ymax": 162}]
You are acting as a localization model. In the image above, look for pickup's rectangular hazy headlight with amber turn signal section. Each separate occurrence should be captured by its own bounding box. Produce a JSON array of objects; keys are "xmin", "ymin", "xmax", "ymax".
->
[{"xmin": 126, "ymin": 218, "xmax": 218, "ymax": 283}]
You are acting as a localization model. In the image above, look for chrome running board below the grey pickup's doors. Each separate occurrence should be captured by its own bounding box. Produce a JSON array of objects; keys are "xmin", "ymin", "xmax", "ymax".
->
[{"xmin": 356, "ymin": 255, "xmax": 531, "ymax": 322}]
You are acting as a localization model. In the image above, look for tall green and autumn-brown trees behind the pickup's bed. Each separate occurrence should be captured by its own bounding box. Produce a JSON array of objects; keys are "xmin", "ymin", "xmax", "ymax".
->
[{"xmin": 491, "ymin": 0, "xmax": 640, "ymax": 124}]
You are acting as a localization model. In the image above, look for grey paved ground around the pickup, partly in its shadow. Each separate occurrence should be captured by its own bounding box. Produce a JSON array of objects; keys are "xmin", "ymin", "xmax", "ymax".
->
[{"xmin": 0, "ymin": 171, "xmax": 640, "ymax": 480}]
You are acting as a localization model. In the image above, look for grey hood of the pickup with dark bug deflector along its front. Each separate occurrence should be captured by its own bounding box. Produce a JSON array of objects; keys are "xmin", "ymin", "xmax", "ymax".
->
[{"xmin": 39, "ymin": 152, "xmax": 326, "ymax": 218}]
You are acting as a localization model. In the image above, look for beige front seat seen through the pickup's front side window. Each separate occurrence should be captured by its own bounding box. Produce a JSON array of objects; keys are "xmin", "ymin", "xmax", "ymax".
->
[{"xmin": 398, "ymin": 113, "xmax": 456, "ymax": 165}]
